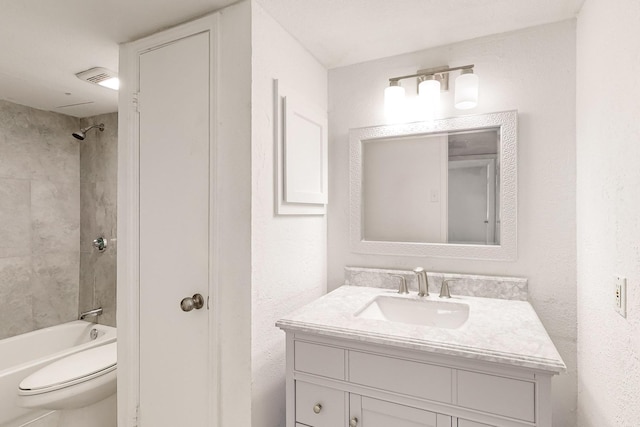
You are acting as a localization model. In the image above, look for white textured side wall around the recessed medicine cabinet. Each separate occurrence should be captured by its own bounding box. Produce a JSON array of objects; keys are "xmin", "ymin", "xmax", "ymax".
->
[{"xmin": 250, "ymin": 1, "xmax": 327, "ymax": 427}]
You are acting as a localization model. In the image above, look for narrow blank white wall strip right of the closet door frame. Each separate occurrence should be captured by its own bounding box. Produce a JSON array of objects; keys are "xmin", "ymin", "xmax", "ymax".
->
[{"xmin": 214, "ymin": 1, "xmax": 252, "ymax": 426}]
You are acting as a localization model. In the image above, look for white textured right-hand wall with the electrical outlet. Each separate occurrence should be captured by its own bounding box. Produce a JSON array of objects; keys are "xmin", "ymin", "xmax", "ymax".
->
[{"xmin": 577, "ymin": 0, "xmax": 640, "ymax": 427}]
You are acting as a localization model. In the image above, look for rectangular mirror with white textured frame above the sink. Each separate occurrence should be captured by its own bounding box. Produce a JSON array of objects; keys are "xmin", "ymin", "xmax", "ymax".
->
[{"xmin": 350, "ymin": 111, "xmax": 518, "ymax": 260}]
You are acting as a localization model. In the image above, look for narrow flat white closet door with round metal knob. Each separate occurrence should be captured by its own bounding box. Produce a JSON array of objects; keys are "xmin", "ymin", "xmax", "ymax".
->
[{"xmin": 139, "ymin": 32, "xmax": 211, "ymax": 427}]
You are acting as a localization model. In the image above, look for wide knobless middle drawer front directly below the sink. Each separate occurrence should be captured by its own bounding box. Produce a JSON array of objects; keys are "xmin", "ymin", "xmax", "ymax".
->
[{"xmin": 349, "ymin": 351, "xmax": 451, "ymax": 403}]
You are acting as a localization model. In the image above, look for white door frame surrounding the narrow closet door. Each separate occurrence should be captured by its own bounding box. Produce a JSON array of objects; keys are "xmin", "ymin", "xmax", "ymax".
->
[{"xmin": 117, "ymin": 13, "xmax": 220, "ymax": 427}]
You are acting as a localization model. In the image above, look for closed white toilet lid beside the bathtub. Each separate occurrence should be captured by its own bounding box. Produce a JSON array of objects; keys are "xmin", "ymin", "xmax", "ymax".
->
[{"xmin": 19, "ymin": 342, "xmax": 117, "ymax": 392}]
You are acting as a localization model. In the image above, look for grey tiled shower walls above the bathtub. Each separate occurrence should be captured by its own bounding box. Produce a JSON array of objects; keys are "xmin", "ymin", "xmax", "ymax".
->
[{"xmin": 0, "ymin": 100, "xmax": 118, "ymax": 339}]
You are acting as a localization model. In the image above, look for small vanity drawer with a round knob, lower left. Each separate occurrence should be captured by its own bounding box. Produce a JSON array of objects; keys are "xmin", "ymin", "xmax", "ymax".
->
[{"xmin": 296, "ymin": 381, "xmax": 347, "ymax": 427}]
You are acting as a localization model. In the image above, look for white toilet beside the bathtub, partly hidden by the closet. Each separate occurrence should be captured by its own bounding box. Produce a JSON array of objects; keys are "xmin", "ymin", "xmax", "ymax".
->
[{"xmin": 18, "ymin": 342, "xmax": 117, "ymax": 410}]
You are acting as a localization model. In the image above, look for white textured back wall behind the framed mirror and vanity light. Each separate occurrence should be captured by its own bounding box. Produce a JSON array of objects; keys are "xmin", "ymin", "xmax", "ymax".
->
[{"xmin": 328, "ymin": 20, "xmax": 576, "ymax": 427}]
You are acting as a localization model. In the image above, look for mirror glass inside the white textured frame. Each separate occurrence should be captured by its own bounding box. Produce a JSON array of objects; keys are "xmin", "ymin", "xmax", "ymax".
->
[{"xmin": 362, "ymin": 127, "xmax": 500, "ymax": 245}]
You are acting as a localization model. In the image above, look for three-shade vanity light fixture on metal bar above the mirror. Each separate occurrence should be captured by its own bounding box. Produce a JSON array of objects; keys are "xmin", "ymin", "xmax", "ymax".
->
[{"xmin": 384, "ymin": 64, "xmax": 478, "ymax": 121}]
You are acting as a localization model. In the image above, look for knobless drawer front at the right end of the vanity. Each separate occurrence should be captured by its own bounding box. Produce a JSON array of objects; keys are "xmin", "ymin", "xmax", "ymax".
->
[{"xmin": 458, "ymin": 371, "xmax": 535, "ymax": 425}]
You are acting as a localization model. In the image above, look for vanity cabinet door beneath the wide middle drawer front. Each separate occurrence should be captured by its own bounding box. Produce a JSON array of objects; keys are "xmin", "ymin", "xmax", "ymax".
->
[{"xmin": 349, "ymin": 394, "xmax": 451, "ymax": 427}]
